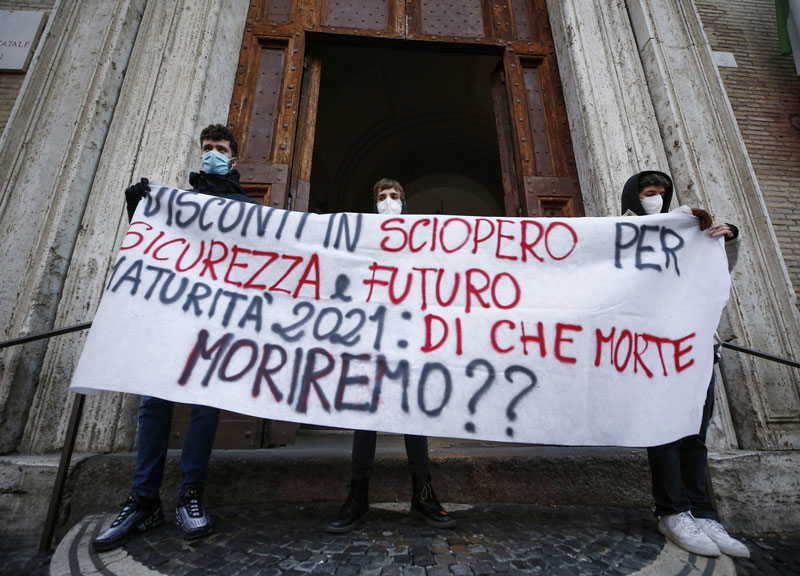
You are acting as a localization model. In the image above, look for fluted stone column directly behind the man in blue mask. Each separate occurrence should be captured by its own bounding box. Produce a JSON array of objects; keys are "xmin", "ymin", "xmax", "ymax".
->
[{"xmin": 22, "ymin": 0, "xmax": 248, "ymax": 452}]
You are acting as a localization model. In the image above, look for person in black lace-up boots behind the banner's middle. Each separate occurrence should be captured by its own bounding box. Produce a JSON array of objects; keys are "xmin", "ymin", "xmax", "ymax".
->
[{"xmin": 325, "ymin": 178, "xmax": 456, "ymax": 534}]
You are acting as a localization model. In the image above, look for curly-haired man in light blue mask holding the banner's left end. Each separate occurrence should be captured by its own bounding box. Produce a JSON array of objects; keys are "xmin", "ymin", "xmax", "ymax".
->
[{"xmin": 92, "ymin": 124, "xmax": 258, "ymax": 551}]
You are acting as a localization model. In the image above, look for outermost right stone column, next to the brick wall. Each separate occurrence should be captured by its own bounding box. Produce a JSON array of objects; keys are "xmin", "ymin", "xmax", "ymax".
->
[{"xmin": 627, "ymin": 0, "xmax": 800, "ymax": 450}]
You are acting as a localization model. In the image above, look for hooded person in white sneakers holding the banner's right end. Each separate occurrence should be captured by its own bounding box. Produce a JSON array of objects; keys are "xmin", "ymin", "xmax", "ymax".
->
[{"xmin": 622, "ymin": 171, "xmax": 750, "ymax": 558}]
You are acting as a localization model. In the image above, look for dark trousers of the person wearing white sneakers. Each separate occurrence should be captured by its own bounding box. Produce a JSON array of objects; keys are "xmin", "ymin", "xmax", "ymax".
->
[{"xmin": 647, "ymin": 372, "xmax": 719, "ymax": 520}]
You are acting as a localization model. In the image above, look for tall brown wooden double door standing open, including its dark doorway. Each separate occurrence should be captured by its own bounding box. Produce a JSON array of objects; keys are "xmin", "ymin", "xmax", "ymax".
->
[{"xmin": 173, "ymin": 0, "xmax": 584, "ymax": 448}]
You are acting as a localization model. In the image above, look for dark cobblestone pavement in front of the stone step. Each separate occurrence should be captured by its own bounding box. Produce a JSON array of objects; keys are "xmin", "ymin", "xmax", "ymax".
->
[{"xmin": 0, "ymin": 503, "xmax": 800, "ymax": 576}]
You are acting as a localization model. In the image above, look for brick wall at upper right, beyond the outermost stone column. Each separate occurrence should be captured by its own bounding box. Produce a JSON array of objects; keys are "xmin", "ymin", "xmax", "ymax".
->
[{"xmin": 696, "ymin": 0, "xmax": 800, "ymax": 295}]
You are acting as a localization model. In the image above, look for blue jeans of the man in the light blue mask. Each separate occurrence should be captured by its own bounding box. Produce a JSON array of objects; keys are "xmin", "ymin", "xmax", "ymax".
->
[{"xmin": 131, "ymin": 396, "xmax": 219, "ymax": 499}]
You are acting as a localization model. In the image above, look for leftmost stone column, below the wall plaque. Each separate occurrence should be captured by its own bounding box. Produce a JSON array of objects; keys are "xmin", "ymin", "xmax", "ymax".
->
[{"xmin": 0, "ymin": 0, "xmax": 146, "ymax": 453}]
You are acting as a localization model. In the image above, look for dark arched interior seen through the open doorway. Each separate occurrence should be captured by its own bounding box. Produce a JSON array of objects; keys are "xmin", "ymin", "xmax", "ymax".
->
[{"xmin": 309, "ymin": 37, "xmax": 503, "ymax": 215}]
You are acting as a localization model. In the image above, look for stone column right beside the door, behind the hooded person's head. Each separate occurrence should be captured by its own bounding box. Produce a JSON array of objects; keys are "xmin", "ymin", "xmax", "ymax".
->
[{"xmin": 547, "ymin": 0, "xmax": 667, "ymax": 216}]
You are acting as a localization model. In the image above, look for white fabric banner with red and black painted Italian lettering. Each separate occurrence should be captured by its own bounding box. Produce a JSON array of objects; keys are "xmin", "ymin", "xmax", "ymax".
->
[{"xmin": 72, "ymin": 184, "xmax": 730, "ymax": 446}]
